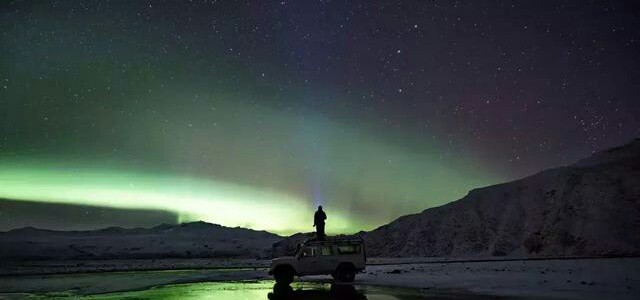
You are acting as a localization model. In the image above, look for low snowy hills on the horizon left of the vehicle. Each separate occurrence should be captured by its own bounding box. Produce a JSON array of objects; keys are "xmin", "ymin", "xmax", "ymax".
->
[{"xmin": 0, "ymin": 222, "xmax": 282, "ymax": 260}]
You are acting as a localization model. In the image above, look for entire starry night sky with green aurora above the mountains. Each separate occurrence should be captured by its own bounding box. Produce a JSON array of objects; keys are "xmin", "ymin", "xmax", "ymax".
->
[{"xmin": 0, "ymin": 0, "xmax": 640, "ymax": 234}]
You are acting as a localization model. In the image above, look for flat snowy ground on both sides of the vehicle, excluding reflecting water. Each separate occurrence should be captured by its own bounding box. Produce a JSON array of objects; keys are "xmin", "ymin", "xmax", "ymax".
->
[{"xmin": 0, "ymin": 258, "xmax": 640, "ymax": 300}]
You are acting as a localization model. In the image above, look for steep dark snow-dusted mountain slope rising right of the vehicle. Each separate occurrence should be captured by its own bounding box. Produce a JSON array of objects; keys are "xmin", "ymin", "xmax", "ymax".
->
[{"xmin": 361, "ymin": 139, "xmax": 640, "ymax": 256}]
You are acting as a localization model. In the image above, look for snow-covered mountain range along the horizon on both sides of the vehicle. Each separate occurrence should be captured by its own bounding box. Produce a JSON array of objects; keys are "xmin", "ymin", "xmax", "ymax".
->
[{"xmin": 5, "ymin": 139, "xmax": 640, "ymax": 260}]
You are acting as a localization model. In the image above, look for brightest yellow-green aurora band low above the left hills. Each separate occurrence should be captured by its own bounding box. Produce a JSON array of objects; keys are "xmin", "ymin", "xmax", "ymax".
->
[{"xmin": 0, "ymin": 163, "xmax": 353, "ymax": 234}]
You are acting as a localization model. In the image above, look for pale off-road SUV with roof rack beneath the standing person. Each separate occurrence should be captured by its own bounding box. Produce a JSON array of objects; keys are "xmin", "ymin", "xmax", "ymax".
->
[{"xmin": 269, "ymin": 238, "xmax": 367, "ymax": 284}]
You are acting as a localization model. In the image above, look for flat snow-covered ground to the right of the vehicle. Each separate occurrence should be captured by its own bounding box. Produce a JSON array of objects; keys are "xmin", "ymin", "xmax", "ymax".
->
[{"xmin": 358, "ymin": 259, "xmax": 640, "ymax": 299}]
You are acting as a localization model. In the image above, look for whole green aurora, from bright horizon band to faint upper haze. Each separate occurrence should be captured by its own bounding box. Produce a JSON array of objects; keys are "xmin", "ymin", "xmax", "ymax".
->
[{"xmin": 0, "ymin": 4, "xmax": 504, "ymax": 234}]
